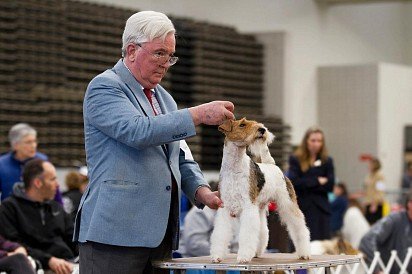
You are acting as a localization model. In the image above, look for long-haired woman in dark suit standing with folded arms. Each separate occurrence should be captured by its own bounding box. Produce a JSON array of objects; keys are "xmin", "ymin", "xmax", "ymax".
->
[{"xmin": 288, "ymin": 127, "xmax": 335, "ymax": 241}]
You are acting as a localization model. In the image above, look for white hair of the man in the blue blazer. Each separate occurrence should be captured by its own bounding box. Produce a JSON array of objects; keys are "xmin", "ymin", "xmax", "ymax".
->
[{"xmin": 122, "ymin": 11, "xmax": 176, "ymax": 57}]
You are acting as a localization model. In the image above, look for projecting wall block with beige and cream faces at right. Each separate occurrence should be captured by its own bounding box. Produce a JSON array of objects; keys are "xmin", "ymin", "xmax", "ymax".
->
[{"xmin": 319, "ymin": 63, "xmax": 412, "ymax": 194}]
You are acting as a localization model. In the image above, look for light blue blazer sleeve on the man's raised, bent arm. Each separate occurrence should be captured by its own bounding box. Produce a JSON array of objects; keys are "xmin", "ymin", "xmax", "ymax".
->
[{"xmin": 83, "ymin": 76, "xmax": 196, "ymax": 149}]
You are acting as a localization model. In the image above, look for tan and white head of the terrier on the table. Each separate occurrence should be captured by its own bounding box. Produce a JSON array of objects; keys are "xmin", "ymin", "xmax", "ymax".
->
[{"xmin": 219, "ymin": 118, "xmax": 274, "ymax": 146}]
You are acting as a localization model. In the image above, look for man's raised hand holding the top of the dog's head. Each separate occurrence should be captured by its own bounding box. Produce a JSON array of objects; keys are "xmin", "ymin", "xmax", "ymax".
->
[{"xmin": 189, "ymin": 101, "xmax": 235, "ymax": 126}]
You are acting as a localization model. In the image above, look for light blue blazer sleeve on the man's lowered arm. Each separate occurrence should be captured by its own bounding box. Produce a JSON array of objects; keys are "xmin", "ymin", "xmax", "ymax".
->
[{"xmin": 179, "ymin": 143, "xmax": 209, "ymax": 207}]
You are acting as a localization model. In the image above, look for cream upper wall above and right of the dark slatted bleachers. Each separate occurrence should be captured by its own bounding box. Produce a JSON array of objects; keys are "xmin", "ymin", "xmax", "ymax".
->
[{"xmin": 85, "ymin": 0, "xmax": 412, "ymax": 144}]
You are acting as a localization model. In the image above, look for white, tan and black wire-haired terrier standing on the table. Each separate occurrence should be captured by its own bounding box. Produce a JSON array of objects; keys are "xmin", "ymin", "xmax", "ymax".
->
[{"xmin": 210, "ymin": 118, "xmax": 310, "ymax": 263}]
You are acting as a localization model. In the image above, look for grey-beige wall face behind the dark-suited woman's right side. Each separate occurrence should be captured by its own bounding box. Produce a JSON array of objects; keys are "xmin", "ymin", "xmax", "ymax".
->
[{"xmin": 318, "ymin": 64, "xmax": 378, "ymax": 190}]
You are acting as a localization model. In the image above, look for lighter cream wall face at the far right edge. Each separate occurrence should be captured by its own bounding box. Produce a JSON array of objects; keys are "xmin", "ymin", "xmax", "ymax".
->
[{"xmin": 378, "ymin": 64, "xmax": 412, "ymax": 188}]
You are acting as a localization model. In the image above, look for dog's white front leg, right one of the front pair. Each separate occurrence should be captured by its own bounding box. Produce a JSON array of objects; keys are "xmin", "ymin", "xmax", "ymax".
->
[{"xmin": 237, "ymin": 204, "xmax": 260, "ymax": 263}]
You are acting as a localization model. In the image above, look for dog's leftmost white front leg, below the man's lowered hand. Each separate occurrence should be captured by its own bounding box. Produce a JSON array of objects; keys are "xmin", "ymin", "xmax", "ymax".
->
[{"xmin": 210, "ymin": 208, "xmax": 233, "ymax": 263}]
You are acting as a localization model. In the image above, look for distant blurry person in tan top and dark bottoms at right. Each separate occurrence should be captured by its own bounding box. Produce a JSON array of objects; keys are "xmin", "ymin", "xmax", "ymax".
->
[{"xmin": 365, "ymin": 157, "xmax": 385, "ymax": 225}]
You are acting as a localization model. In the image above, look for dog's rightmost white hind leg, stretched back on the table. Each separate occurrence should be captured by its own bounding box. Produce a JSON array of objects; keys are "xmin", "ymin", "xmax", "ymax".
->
[{"xmin": 275, "ymin": 188, "xmax": 310, "ymax": 259}]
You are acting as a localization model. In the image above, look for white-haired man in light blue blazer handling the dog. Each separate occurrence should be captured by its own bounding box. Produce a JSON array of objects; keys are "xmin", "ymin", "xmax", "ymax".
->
[{"xmin": 74, "ymin": 11, "xmax": 234, "ymax": 274}]
